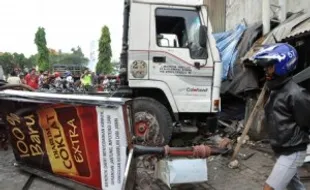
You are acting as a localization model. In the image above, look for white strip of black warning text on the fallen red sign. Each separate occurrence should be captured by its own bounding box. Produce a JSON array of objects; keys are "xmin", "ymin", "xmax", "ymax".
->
[{"xmin": 97, "ymin": 107, "xmax": 127, "ymax": 190}]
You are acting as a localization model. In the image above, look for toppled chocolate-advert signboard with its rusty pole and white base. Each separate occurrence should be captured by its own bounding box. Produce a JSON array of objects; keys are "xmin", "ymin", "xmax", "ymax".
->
[{"xmin": 0, "ymin": 90, "xmax": 230, "ymax": 190}]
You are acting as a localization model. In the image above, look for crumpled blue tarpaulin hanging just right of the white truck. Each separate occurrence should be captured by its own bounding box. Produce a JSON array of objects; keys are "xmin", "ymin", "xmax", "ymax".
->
[{"xmin": 213, "ymin": 24, "xmax": 246, "ymax": 80}]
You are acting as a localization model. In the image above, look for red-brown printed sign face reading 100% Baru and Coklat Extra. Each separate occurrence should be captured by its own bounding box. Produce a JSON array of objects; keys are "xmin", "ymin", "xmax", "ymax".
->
[{"xmin": 6, "ymin": 104, "xmax": 127, "ymax": 190}]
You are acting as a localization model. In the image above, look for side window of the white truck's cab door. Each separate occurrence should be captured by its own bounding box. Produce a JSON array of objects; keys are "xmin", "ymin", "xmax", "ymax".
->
[{"xmin": 156, "ymin": 8, "xmax": 207, "ymax": 59}]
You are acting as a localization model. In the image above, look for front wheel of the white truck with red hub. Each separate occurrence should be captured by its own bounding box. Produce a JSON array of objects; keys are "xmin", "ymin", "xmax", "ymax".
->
[{"xmin": 133, "ymin": 97, "xmax": 172, "ymax": 146}]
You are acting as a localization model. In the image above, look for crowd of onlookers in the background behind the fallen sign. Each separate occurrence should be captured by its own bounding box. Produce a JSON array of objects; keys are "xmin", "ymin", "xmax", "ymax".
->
[{"xmin": 7, "ymin": 69, "xmax": 119, "ymax": 91}]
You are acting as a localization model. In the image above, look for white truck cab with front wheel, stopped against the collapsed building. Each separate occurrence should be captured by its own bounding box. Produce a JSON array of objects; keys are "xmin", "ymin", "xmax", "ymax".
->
[{"xmin": 114, "ymin": 0, "xmax": 222, "ymax": 144}]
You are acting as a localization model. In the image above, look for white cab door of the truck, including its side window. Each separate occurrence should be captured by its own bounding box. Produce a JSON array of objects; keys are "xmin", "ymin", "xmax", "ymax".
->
[{"xmin": 149, "ymin": 5, "xmax": 213, "ymax": 112}]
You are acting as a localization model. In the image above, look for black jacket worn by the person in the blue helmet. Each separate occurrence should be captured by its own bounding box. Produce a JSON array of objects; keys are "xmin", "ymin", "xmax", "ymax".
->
[{"xmin": 265, "ymin": 79, "xmax": 310, "ymax": 154}]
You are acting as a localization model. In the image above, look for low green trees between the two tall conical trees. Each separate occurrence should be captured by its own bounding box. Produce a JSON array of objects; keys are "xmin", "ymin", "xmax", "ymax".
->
[{"xmin": 50, "ymin": 46, "xmax": 89, "ymax": 66}]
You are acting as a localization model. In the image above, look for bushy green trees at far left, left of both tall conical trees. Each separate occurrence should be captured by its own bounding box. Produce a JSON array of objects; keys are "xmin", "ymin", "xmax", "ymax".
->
[{"xmin": 0, "ymin": 52, "xmax": 36, "ymax": 74}]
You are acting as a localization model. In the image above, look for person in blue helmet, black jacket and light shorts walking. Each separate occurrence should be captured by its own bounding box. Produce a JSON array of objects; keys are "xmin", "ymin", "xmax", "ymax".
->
[{"xmin": 251, "ymin": 43, "xmax": 310, "ymax": 190}]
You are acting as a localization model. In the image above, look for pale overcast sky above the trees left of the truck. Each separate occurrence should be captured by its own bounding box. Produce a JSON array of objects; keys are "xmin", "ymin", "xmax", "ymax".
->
[{"xmin": 0, "ymin": 0, "xmax": 123, "ymax": 61}]
